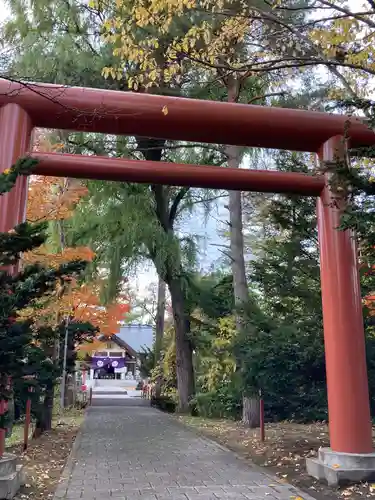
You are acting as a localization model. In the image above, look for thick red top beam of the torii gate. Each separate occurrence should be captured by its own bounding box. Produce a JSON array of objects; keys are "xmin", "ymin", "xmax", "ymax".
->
[{"xmin": 0, "ymin": 79, "xmax": 375, "ymax": 152}]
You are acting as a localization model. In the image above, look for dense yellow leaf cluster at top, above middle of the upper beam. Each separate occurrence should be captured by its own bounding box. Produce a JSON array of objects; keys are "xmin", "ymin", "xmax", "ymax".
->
[{"xmin": 90, "ymin": 0, "xmax": 251, "ymax": 90}]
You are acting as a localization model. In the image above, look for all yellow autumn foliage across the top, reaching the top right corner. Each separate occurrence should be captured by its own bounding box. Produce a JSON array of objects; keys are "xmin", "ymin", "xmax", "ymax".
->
[{"xmin": 95, "ymin": 0, "xmax": 375, "ymax": 96}]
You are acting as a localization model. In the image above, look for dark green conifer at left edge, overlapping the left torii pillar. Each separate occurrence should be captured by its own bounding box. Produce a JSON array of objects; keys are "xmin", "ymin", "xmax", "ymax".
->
[{"xmin": 0, "ymin": 158, "xmax": 87, "ymax": 428}]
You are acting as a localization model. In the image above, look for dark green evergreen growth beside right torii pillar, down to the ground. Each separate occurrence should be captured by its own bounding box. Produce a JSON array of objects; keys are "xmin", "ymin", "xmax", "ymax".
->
[{"xmin": 235, "ymin": 152, "xmax": 326, "ymax": 419}]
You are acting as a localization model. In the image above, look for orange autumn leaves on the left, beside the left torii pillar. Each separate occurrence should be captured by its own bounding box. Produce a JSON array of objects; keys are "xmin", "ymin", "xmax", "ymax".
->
[{"xmin": 23, "ymin": 136, "xmax": 129, "ymax": 334}]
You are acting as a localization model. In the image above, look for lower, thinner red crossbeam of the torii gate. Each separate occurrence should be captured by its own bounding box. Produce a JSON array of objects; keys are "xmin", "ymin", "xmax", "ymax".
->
[{"xmin": 32, "ymin": 153, "xmax": 324, "ymax": 196}]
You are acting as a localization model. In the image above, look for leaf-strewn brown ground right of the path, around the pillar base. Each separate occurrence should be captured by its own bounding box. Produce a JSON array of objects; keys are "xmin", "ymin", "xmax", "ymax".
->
[{"xmin": 178, "ymin": 416, "xmax": 375, "ymax": 500}]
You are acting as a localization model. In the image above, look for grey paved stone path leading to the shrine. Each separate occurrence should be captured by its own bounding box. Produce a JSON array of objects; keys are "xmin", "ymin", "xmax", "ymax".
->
[{"xmin": 55, "ymin": 400, "xmax": 312, "ymax": 500}]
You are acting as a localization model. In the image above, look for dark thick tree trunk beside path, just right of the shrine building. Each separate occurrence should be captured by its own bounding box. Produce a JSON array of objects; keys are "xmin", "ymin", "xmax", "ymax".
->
[{"xmin": 167, "ymin": 277, "xmax": 195, "ymax": 413}]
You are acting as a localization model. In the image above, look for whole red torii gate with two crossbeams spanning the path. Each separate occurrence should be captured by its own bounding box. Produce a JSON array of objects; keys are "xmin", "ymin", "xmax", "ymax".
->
[{"xmin": 0, "ymin": 79, "xmax": 375, "ymax": 482}]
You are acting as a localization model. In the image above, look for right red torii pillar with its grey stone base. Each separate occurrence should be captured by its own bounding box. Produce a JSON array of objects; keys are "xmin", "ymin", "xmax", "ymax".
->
[{"xmin": 307, "ymin": 136, "xmax": 375, "ymax": 485}]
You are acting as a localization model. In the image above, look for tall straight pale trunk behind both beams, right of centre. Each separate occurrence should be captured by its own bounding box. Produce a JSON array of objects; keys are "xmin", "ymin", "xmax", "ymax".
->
[{"xmin": 225, "ymin": 78, "xmax": 260, "ymax": 428}]
